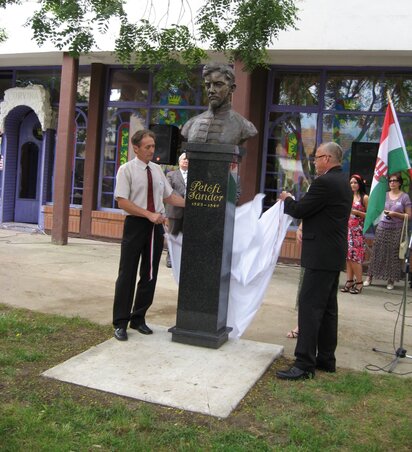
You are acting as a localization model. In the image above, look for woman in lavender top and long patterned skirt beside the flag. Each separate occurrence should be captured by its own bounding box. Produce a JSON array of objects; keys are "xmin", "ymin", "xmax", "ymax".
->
[{"xmin": 364, "ymin": 173, "xmax": 412, "ymax": 290}]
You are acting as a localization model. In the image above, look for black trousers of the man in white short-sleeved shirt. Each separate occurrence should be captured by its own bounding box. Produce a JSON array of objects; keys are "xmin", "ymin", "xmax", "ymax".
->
[{"xmin": 113, "ymin": 216, "xmax": 164, "ymax": 328}]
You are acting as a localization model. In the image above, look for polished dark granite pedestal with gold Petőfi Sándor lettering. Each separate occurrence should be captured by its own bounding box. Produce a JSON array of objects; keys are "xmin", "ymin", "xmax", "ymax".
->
[{"xmin": 169, "ymin": 143, "xmax": 240, "ymax": 348}]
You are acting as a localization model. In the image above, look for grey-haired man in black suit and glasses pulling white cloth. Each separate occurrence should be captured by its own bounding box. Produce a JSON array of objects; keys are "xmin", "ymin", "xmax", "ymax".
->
[{"xmin": 276, "ymin": 142, "xmax": 353, "ymax": 380}]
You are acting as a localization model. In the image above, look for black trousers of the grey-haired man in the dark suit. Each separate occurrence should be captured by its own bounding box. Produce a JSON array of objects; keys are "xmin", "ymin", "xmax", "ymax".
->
[{"xmin": 295, "ymin": 268, "xmax": 340, "ymax": 371}]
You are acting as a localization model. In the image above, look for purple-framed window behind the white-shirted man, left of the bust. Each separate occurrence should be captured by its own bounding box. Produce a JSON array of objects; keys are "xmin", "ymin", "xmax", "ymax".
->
[{"xmin": 99, "ymin": 68, "xmax": 207, "ymax": 209}]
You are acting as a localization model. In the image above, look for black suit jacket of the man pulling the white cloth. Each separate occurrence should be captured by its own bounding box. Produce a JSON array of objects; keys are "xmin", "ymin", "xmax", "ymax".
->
[{"xmin": 284, "ymin": 166, "xmax": 353, "ymax": 271}]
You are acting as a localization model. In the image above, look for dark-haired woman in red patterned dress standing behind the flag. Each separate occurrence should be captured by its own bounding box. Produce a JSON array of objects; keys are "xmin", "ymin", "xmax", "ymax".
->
[{"xmin": 340, "ymin": 174, "xmax": 369, "ymax": 295}]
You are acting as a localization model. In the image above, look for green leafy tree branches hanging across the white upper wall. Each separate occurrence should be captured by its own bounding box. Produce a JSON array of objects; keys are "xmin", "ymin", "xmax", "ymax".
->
[{"xmin": 0, "ymin": 0, "xmax": 297, "ymax": 87}]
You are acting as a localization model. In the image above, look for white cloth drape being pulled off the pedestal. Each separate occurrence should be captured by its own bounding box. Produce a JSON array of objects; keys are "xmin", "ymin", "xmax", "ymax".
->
[{"xmin": 166, "ymin": 194, "xmax": 292, "ymax": 338}]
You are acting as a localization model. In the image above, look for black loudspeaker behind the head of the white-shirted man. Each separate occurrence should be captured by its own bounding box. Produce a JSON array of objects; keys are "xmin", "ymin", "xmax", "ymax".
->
[{"xmin": 149, "ymin": 124, "xmax": 179, "ymax": 165}]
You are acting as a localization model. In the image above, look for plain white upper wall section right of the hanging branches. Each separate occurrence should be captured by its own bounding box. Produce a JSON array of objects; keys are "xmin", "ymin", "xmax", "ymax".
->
[{"xmin": 273, "ymin": 0, "xmax": 412, "ymax": 51}]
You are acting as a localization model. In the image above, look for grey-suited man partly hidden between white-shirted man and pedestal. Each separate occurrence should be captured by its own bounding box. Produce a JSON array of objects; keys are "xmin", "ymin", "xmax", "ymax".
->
[{"xmin": 166, "ymin": 152, "xmax": 189, "ymax": 268}]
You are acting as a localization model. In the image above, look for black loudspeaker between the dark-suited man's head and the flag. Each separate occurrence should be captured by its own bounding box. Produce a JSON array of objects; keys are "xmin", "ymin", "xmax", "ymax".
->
[{"xmin": 350, "ymin": 141, "xmax": 379, "ymax": 194}]
